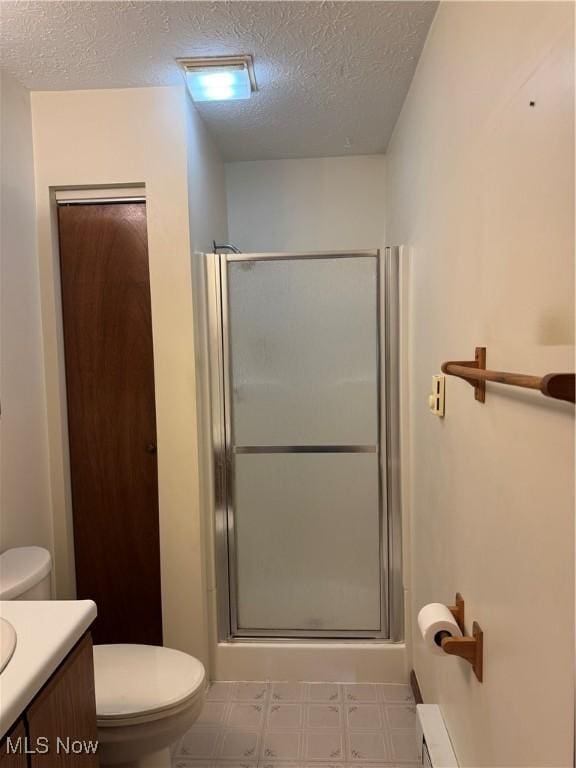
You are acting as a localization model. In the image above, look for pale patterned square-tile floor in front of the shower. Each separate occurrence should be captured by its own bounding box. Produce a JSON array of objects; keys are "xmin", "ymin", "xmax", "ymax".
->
[{"xmin": 172, "ymin": 682, "xmax": 419, "ymax": 768}]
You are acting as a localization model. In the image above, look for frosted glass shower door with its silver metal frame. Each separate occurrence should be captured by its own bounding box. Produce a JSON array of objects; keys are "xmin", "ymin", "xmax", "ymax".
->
[{"xmin": 206, "ymin": 248, "xmax": 403, "ymax": 641}]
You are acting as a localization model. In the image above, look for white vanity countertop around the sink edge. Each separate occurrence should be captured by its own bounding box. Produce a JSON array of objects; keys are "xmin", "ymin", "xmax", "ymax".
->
[{"xmin": 0, "ymin": 600, "xmax": 96, "ymax": 738}]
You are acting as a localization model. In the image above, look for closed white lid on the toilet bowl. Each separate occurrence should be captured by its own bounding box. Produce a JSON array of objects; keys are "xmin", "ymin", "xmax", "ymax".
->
[{"xmin": 94, "ymin": 645, "xmax": 205, "ymax": 720}]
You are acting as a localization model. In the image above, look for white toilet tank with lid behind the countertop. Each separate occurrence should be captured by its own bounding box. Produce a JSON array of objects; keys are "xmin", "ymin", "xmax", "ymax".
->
[{"xmin": 0, "ymin": 547, "xmax": 52, "ymax": 600}]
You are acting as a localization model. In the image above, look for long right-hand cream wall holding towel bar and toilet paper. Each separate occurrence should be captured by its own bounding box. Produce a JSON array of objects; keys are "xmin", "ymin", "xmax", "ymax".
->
[{"xmin": 386, "ymin": 2, "xmax": 574, "ymax": 767}]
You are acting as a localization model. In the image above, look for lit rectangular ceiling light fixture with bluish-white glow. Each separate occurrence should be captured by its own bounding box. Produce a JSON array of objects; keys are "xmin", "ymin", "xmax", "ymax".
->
[{"xmin": 177, "ymin": 54, "xmax": 256, "ymax": 101}]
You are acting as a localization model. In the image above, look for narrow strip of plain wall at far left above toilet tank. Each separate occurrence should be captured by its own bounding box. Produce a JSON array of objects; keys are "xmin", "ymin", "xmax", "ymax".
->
[{"xmin": 0, "ymin": 71, "xmax": 52, "ymax": 550}]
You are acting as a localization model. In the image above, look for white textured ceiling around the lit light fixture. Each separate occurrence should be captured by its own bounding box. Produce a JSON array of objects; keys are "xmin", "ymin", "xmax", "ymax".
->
[{"xmin": 0, "ymin": 0, "xmax": 437, "ymax": 160}]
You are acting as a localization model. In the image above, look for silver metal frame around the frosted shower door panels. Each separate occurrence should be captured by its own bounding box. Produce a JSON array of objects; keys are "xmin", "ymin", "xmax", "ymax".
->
[{"xmin": 206, "ymin": 247, "xmax": 403, "ymax": 642}]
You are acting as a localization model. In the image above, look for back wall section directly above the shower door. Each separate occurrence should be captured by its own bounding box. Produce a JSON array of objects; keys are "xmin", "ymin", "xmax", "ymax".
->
[{"xmin": 226, "ymin": 155, "xmax": 384, "ymax": 252}]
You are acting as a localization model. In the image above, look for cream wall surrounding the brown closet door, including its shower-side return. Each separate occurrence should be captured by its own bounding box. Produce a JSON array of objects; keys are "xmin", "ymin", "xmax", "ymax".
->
[{"xmin": 32, "ymin": 87, "xmax": 226, "ymax": 662}]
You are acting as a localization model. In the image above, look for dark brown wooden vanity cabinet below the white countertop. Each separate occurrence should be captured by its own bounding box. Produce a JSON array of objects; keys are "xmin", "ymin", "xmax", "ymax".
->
[{"xmin": 0, "ymin": 633, "xmax": 100, "ymax": 768}]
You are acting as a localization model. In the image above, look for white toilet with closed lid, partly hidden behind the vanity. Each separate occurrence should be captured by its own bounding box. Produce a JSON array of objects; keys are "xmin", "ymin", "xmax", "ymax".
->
[{"xmin": 0, "ymin": 547, "xmax": 206, "ymax": 768}]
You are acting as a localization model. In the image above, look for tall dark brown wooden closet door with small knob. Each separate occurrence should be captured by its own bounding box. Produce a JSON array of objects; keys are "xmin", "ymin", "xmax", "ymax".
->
[{"xmin": 58, "ymin": 203, "xmax": 162, "ymax": 644}]
